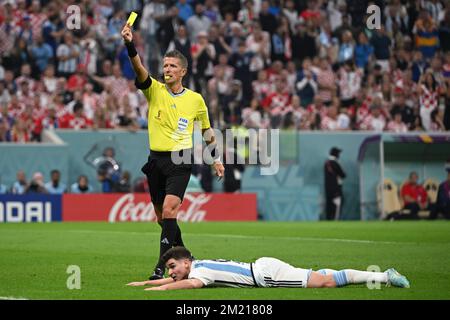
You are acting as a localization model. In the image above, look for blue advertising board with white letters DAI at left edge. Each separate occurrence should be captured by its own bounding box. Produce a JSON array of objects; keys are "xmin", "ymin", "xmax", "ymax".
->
[{"xmin": 0, "ymin": 194, "xmax": 62, "ymax": 223}]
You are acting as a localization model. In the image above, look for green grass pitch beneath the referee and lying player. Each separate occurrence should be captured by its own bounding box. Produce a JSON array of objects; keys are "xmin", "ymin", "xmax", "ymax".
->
[{"xmin": 0, "ymin": 221, "xmax": 450, "ymax": 300}]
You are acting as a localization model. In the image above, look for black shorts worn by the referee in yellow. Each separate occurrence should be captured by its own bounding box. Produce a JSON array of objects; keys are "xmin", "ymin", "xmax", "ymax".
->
[{"xmin": 141, "ymin": 149, "xmax": 192, "ymax": 205}]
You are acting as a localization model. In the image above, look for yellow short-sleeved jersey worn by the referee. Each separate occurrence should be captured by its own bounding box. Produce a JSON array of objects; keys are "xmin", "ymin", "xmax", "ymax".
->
[{"xmin": 136, "ymin": 78, "xmax": 211, "ymax": 151}]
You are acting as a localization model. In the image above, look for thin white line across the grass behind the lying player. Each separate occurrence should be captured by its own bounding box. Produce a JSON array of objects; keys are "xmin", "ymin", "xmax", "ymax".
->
[{"xmin": 65, "ymin": 230, "xmax": 414, "ymax": 244}]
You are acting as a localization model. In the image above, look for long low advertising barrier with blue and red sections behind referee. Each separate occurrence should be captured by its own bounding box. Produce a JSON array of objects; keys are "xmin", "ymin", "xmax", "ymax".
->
[{"xmin": 0, "ymin": 193, "xmax": 257, "ymax": 223}]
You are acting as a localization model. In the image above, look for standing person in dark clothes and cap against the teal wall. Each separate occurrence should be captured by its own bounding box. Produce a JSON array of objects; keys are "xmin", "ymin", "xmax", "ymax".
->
[{"xmin": 324, "ymin": 147, "xmax": 346, "ymax": 220}]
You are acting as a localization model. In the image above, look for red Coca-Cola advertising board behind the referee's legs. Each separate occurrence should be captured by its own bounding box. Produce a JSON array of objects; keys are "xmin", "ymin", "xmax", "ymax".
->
[{"xmin": 62, "ymin": 193, "xmax": 257, "ymax": 222}]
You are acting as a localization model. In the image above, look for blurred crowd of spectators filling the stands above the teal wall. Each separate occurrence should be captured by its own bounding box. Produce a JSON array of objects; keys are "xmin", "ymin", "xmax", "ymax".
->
[{"xmin": 0, "ymin": 0, "xmax": 450, "ymax": 142}]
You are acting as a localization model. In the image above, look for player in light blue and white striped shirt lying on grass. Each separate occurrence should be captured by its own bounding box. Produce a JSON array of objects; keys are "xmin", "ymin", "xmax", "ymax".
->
[{"xmin": 128, "ymin": 247, "xmax": 409, "ymax": 290}]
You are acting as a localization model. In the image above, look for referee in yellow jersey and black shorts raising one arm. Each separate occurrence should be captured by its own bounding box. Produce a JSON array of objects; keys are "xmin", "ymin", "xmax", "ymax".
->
[{"xmin": 122, "ymin": 24, "xmax": 225, "ymax": 280}]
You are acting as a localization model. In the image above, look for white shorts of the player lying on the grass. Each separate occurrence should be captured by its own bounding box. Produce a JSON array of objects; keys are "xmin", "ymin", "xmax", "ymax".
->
[{"xmin": 253, "ymin": 257, "xmax": 312, "ymax": 288}]
